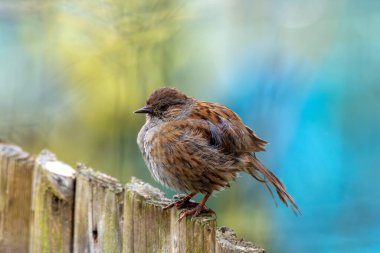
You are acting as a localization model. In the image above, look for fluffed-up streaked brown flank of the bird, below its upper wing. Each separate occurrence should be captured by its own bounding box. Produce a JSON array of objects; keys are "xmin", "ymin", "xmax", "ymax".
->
[{"xmin": 151, "ymin": 119, "xmax": 240, "ymax": 193}]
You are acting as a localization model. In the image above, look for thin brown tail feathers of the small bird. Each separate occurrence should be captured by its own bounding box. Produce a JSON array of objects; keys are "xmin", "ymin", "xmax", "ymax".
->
[{"xmin": 247, "ymin": 156, "xmax": 301, "ymax": 215}]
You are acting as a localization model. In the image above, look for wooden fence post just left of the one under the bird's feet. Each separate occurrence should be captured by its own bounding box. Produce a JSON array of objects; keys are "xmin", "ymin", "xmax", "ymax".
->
[{"xmin": 123, "ymin": 178, "xmax": 171, "ymax": 253}]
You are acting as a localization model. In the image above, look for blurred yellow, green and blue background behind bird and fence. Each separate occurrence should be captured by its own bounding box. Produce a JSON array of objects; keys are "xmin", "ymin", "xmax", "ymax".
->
[{"xmin": 0, "ymin": 0, "xmax": 380, "ymax": 252}]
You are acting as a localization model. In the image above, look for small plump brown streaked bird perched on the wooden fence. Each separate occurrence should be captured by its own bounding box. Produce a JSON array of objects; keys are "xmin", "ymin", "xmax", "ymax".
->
[{"xmin": 135, "ymin": 88, "xmax": 300, "ymax": 220}]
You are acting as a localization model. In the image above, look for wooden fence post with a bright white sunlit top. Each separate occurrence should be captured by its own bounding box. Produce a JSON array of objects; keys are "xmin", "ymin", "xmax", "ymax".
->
[{"xmin": 29, "ymin": 151, "xmax": 75, "ymax": 253}]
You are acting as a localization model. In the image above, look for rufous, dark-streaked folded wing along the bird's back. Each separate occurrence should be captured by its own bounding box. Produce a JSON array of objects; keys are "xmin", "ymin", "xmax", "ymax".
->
[{"xmin": 190, "ymin": 101, "xmax": 268, "ymax": 153}]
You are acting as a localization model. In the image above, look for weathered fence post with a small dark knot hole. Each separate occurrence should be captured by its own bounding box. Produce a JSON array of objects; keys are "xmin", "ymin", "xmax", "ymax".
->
[{"xmin": 74, "ymin": 165, "xmax": 123, "ymax": 253}]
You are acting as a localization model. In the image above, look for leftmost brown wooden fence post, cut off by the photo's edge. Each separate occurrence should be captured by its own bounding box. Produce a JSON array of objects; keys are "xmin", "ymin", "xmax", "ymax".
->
[{"xmin": 0, "ymin": 143, "xmax": 34, "ymax": 253}]
